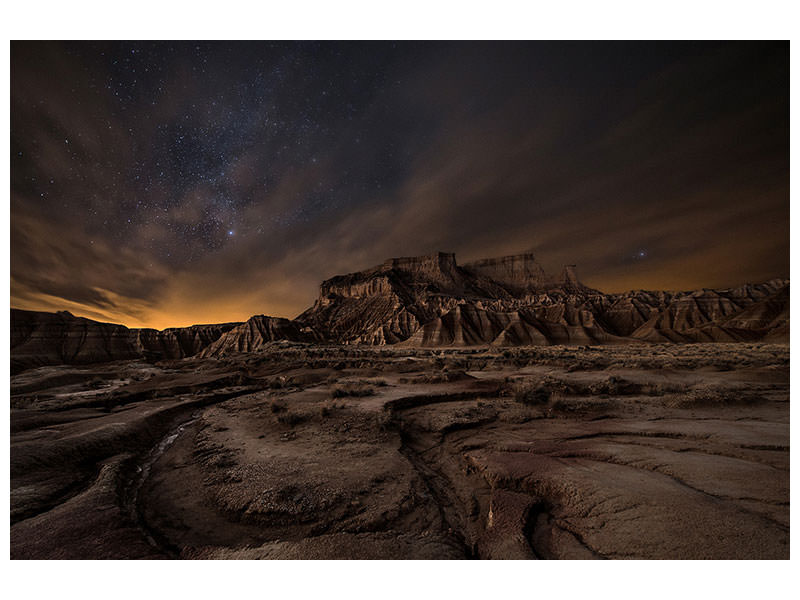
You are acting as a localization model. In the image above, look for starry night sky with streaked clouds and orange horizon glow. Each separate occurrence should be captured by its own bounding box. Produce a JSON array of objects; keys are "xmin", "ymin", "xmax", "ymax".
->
[{"xmin": 10, "ymin": 42, "xmax": 789, "ymax": 328}]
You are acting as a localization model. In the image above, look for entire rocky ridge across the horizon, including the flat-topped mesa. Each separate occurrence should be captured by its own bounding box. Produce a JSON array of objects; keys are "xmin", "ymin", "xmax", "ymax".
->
[{"xmin": 11, "ymin": 252, "xmax": 789, "ymax": 373}]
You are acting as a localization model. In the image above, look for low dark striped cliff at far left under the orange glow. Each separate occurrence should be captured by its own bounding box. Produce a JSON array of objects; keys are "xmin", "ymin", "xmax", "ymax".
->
[{"xmin": 11, "ymin": 308, "xmax": 238, "ymax": 374}]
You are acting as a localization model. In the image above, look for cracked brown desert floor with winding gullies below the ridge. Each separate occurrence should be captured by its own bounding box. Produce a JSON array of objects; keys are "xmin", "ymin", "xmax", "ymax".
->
[{"xmin": 11, "ymin": 342, "xmax": 789, "ymax": 559}]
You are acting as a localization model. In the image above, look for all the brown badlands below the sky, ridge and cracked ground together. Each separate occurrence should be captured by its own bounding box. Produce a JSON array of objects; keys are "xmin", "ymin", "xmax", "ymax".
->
[{"xmin": 10, "ymin": 254, "xmax": 789, "ymax": 559}]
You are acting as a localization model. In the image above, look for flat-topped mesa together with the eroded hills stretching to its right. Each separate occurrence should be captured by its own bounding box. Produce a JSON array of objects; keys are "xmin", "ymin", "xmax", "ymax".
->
[{"xmin": 298, "ymin": 253, "xmax": 788, "ymax": 346}]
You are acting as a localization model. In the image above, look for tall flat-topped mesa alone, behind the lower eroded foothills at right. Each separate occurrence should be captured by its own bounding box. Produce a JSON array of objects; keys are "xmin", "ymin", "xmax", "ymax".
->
[{"xmin": 297, "ymin": 252, "xmax": 599, "ymax": 344}]
